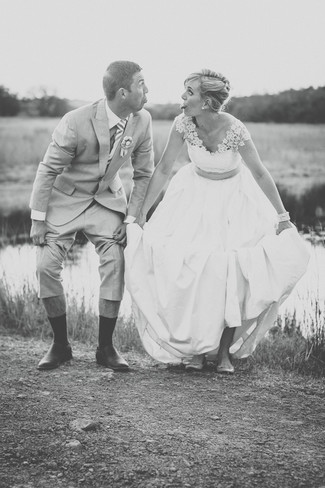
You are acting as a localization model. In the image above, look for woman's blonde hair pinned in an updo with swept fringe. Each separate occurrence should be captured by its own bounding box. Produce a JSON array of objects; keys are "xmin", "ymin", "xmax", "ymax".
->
[{"xmin": 184, "ymin": 69, "xmax": 230, "ymax": 112}]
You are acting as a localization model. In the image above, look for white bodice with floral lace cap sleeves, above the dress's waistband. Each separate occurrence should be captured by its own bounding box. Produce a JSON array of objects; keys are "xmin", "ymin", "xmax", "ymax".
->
[{"xmin": 175, "ymin": 114, "xmax": 250, "ymax": 172}]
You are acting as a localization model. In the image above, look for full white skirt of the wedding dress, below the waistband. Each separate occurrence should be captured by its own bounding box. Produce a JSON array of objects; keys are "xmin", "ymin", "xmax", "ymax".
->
[{"xmin": 125, "ymin": 163, "xmax": 309, "ymax": 363}]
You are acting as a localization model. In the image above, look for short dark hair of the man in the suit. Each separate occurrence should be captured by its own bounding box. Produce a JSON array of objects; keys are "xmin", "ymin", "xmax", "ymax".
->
[{"xmin": 103, "ymin": 61, "xmax": 142, "ymax": 100}]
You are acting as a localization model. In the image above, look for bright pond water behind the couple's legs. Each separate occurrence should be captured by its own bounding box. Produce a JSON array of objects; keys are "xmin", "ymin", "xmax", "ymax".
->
[{"xmin": 0, "ymin": 235, "xmax": 325, "ymax": 334}]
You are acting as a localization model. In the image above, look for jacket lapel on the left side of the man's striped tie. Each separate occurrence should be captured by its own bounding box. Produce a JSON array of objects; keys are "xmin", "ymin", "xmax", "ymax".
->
[{"xmin": 92, "ymin": 99, "xmax": 110, "ymax": 176}]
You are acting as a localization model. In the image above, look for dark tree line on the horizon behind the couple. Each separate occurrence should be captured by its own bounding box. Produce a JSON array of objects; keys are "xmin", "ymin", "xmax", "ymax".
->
[{"xmin": 0, "ymin": 85, "xmax": 325, "ymax": 124}]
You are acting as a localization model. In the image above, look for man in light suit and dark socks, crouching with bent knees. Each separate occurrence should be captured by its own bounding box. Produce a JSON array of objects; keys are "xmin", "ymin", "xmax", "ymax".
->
[{"xmin": 30, "ymin": 61, "xmax": 153, "ymax": 370}]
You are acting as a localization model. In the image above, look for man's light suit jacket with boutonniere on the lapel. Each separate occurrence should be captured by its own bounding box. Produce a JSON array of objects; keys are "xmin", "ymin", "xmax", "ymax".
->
[{"xmin": 30, "ymin": 99, "xmax": 153, "ymax": 225}]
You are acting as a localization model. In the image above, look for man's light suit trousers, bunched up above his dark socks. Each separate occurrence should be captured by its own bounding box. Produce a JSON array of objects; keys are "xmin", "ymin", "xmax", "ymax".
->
[{"xmin": 36, "ymin": 203, "xmax": 124, "ymax": 301}]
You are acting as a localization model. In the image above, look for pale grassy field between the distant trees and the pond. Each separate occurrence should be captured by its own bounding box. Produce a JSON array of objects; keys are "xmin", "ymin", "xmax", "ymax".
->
[{"xmin": 0, "ymin": 117, "xmax": 325, "ymax": 215}]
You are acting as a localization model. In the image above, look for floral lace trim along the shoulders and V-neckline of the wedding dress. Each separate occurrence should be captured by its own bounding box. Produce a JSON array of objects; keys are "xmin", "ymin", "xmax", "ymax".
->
[{"xmin": 175, "ymin": 114, "xmax": 251, "ymax": 154}]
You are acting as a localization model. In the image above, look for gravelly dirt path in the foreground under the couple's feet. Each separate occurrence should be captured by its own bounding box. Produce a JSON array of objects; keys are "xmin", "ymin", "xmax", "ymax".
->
[{"xmin": 0, "ymin": 337, "xmax": 325, "ymax": 488}]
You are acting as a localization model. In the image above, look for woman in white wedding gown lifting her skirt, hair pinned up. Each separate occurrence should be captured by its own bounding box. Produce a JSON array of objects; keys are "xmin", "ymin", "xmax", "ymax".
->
[{"xmin": 125, "ymin": 69, "xmax": 309, "ymax": 373}]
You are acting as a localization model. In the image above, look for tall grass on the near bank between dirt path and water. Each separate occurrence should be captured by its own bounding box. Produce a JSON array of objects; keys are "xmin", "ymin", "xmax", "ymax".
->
[{"xmin": 0, "ymin": 274, "xmax": 325, "ymax": 376}]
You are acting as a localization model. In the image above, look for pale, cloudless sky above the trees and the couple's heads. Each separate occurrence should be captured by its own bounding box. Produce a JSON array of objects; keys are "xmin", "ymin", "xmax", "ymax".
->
[{"xmin": 0, "ymin": 0, "xmax": 325, "ymax": 103}]
